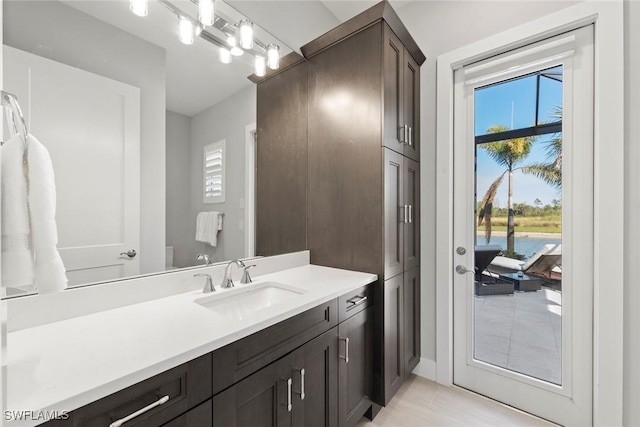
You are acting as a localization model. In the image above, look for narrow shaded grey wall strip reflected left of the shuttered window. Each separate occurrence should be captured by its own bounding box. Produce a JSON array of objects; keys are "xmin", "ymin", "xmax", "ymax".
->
[{"xmin": 167, "ymin": 111, "xmax": 190, "ymax": 267}]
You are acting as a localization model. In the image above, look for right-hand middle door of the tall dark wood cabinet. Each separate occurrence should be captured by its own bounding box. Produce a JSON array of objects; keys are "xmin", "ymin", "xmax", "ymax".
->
[{"xmin": 402, "ymin": 158, "xmax": 420, "ymax": 271}]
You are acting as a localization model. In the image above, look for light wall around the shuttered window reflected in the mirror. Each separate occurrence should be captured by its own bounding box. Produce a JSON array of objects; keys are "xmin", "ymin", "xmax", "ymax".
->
[{"xmin": 189, "ymin": 85, "xmax": 257, "ymax": 261}]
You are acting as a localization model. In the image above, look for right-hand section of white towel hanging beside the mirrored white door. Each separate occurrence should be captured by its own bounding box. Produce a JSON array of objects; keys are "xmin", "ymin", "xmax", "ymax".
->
[{"xmin": 27, "ymin": 135, "xmax": 67, "ymax": 294}]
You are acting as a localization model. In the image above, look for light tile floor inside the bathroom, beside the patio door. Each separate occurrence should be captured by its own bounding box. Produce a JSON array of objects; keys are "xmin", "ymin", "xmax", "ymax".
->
[{"xmin": 356, "ymin": 375, "xmax": 555, "ymax": 427}]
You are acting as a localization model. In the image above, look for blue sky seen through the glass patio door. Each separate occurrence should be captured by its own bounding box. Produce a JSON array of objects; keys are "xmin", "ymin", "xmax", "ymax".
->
[{"xmin": 474, "ymin": 67, "xmax": 562, "ymax": 207}]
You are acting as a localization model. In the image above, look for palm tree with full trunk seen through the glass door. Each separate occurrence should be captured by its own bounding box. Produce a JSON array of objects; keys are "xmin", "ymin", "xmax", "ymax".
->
[{"xmin": 478, "ymin": 125, "xmax": 536, "ymax": 254}]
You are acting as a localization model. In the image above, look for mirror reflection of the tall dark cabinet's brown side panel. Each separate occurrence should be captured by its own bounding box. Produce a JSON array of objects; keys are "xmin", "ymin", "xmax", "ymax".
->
[{"xmin": 256, "ymin": 62, "xmax": 307, "ymax": 256}]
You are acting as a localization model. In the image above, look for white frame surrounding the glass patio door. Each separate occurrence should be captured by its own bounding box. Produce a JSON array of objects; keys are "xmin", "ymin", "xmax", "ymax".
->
[{"xmin": 436, "ymin": 0, "xmax": 624, "ymax": 425}]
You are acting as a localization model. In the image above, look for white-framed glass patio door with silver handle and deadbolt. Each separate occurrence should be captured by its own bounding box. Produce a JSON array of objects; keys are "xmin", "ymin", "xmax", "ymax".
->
[{"xmin": 453, "ymin": 27, "xmax": 593, "ymax": 425}]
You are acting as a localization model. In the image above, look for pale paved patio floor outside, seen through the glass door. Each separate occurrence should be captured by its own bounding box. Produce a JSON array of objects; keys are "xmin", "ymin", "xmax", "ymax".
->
[{"xmin": 474, "ymin": 287, "xmax": 562, "ymax": 384}]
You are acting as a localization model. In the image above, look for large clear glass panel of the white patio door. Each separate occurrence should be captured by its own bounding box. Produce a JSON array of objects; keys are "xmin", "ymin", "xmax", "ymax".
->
[{"xmin": 473, "ymin": 67, "xmax": 562, "ymax": 384}]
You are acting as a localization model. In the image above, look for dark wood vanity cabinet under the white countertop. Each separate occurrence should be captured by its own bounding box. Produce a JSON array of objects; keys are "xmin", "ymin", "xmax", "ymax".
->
[{"xmin": 46, "ymin": 284, "xmax": 374, "ymax": 427}]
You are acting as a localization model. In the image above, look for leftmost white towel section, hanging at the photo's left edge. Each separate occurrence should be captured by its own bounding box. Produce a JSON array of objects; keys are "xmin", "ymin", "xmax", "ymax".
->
[{"xmin": 0, "ymin": 135, "xmax": 34, "ymax": 291}]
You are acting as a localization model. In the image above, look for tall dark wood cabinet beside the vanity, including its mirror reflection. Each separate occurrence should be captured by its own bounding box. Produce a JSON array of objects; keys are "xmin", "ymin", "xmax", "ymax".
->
[{"xmin": 257, "ymin": 2, "xmax": 425, "ymax": 416}]
